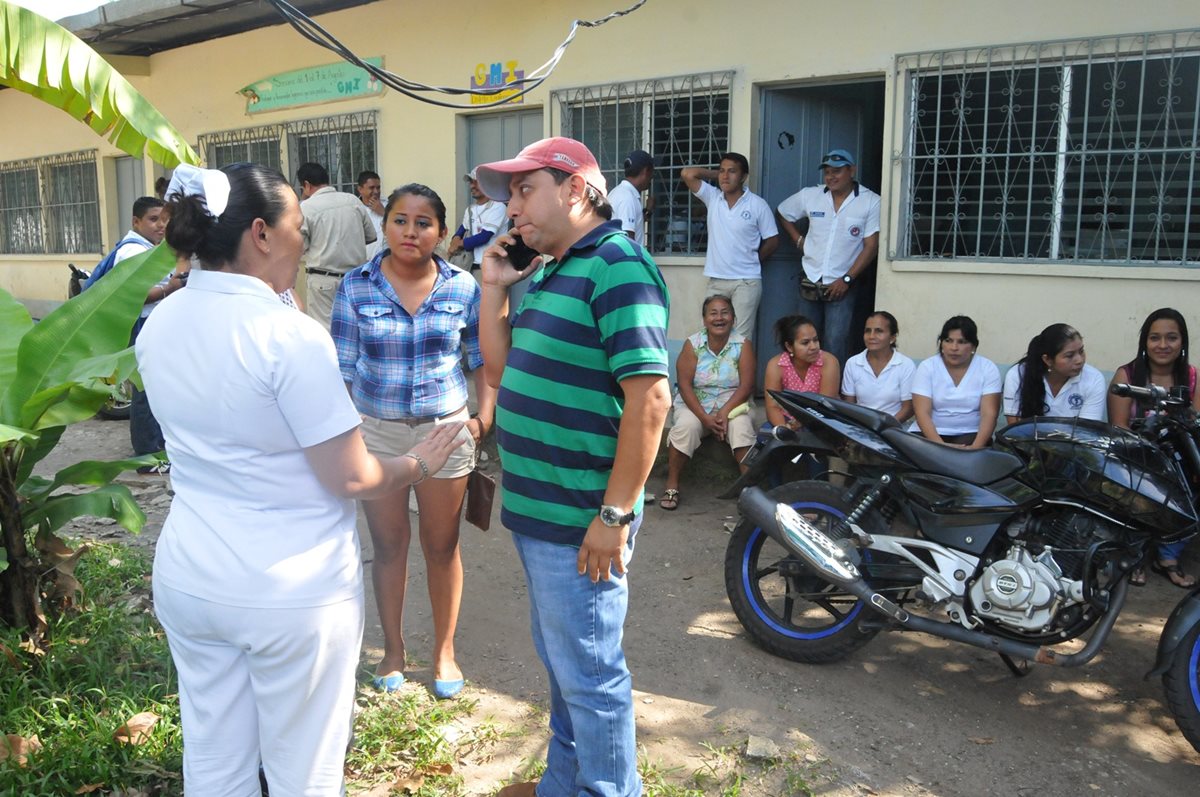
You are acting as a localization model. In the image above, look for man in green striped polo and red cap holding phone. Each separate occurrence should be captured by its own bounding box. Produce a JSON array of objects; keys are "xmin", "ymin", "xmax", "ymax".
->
[{"xmin": 476, "ymin": 138, "xmax": 671, "ymax": 797}]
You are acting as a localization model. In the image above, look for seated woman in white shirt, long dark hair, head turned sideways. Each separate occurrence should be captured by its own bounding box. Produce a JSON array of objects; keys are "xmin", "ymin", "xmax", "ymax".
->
[{"xmin": 1004, "ymin": 324, "xmax": 1108, "ymax": 424}]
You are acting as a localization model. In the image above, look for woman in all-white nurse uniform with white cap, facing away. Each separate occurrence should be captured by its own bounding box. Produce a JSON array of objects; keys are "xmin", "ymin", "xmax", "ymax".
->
[{"xmin": 136, "ymin": 163, "xmax": 461, "ymax": 797}]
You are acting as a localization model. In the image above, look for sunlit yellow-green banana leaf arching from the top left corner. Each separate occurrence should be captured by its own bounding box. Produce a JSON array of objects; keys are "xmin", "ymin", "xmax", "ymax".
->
[{"xmin": 0, "ymin": 0, "xmax": 200, "ymax": 168}]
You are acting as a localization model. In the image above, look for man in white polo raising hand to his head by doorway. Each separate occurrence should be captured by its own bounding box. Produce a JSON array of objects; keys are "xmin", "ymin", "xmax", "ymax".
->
[{"xmin": 679, "ymin": 152, "xmax": 779, "ymax": 340}]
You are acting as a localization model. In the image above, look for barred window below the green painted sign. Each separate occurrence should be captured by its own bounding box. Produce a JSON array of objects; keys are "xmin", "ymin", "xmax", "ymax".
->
[{"xmin": 199, "ymin": 110, "xmax": 377, "ymax": 193}]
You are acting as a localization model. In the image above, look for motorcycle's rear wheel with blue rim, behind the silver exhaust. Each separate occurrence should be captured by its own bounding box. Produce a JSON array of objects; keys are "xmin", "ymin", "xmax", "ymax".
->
[{"xmin": 725, "ymin": 481, "xmax": 887, "ymax": 664}]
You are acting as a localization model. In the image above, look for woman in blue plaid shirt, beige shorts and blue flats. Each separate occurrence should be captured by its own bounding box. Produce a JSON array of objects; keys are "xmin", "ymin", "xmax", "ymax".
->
[{"xmin": 331, "ymin": 182, "xmax": 496, "ymax": 697}]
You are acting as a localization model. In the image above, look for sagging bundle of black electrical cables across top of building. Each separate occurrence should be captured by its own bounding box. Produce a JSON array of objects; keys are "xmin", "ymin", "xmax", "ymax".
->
[{"xmin": 266, "ymin": 0, "xmax": 647, "ymax": 109}]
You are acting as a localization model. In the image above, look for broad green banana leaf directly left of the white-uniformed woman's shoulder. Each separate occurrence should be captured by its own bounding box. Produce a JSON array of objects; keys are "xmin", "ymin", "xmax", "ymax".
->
[{"xmin": 0, "ymin": 244, "xmax": 175, "ymax": 430}]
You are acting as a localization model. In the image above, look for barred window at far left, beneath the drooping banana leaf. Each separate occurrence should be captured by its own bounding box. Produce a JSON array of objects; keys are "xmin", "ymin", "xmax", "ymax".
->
[{"xmin": 0, "ymin": 150, "xmax": 102, "ymax": 254}]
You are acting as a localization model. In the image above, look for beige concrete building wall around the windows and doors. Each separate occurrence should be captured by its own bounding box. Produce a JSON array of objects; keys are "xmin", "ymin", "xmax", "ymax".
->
[{"xmin": 0, "ymin": 0, "xmax": 1200, "ymax": 360}]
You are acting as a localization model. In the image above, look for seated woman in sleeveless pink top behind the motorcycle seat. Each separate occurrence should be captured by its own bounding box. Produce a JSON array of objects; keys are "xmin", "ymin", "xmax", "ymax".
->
[{"xmin": 762, "ymin": 316, "xmax": 841, "ymax": 429}]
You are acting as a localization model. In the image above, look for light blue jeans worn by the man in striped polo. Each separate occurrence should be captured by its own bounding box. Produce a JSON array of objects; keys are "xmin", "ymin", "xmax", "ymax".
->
[{"xmin": 512, "ymin": 515, "xmax": 642, "ymax": 797}]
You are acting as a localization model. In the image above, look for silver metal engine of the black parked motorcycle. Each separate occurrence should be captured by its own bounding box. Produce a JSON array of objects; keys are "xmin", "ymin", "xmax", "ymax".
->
[{"xmin": 971, "ymin": 545, "xmax": 1084, "ymax": 631}]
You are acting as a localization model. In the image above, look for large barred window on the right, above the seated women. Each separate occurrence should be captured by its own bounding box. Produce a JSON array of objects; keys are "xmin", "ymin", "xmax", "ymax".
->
[{"xmin": 896, "ymin": 30, "xmax": 1200, "ymax": 265}]
